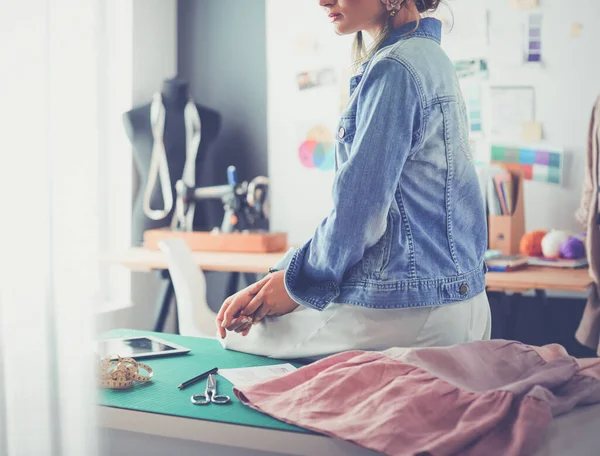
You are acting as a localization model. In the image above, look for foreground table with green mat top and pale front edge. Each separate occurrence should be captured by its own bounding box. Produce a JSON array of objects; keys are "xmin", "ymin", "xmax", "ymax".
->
[{"xmin": 97, "ymin": 329, "xmax": 600, "ymax": 456}]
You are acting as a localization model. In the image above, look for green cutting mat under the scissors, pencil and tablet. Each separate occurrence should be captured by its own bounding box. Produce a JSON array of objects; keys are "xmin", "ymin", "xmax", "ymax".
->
[{"xmin": 99, "ymin": 329, "xmax": 311, "ymax": 434}]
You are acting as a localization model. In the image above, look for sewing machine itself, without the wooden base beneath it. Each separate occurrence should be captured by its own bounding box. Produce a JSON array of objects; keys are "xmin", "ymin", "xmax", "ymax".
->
[{"xmin": 171, "ymin": 166, "xmax": 269, "ymax": 233}]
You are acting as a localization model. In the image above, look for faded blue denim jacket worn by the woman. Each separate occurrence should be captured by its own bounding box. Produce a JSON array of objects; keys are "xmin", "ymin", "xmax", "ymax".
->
[{"xmin": 283, "ymin": 18, "xmax": 487, "ymax": 310}]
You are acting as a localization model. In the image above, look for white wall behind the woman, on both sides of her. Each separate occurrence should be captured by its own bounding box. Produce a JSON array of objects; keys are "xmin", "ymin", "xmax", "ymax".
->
[{"xmin": 267, "ymin": 0, "xmax": 600, "ymax": 242}]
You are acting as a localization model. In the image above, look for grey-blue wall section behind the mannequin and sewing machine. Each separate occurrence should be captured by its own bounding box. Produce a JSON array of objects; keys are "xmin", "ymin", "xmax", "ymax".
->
[{"xmin": 178, "ymin": 0, "xmax": 267, "ymax": 309}]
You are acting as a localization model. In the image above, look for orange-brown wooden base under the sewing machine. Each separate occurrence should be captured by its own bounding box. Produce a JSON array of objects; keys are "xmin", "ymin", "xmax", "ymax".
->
[{"xmin": 144, "ymin": 228, "xmax": 288, "ymax": 253}]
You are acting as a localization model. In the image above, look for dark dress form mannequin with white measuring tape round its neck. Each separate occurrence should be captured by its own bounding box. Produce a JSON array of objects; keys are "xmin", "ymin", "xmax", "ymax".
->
[{"xmin": 123, "ymin": 78, "xmax": 221, "ymax": 246}]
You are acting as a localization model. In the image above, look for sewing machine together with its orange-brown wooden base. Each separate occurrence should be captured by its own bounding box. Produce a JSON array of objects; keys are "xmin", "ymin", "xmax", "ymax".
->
[{"xmin": 144, "ymin": 166, "xmax": 287, "ymax": 253}]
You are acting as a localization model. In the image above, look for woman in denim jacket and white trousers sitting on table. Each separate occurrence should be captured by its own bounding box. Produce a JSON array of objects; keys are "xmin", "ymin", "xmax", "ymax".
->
[{"xmin": 217, "ymin": 0, "xmax": 490, "ymax": 358}]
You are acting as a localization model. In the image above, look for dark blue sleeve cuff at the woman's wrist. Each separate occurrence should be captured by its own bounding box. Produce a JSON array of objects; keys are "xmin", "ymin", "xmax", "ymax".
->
[{"xmin": 284, "ymin": 243, "xmax": 340, "ymax": 310}]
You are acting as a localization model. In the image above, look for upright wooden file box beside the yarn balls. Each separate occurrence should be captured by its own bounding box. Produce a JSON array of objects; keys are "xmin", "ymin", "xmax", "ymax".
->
[{"xmin": 488, "ymin": 166, "xmax": 525, "ymax": 255}]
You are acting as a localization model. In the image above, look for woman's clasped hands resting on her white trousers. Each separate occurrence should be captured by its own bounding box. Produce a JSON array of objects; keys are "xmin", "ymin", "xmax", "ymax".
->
[{"xmin": 217, "ymin": 271, "xmax": 298, "ymax": 338}]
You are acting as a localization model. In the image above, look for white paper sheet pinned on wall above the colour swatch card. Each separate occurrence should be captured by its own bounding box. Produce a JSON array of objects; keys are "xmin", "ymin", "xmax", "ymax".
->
[{"xmin": 490, "ymin": 86, "xmax": 535, "ymax": 140}]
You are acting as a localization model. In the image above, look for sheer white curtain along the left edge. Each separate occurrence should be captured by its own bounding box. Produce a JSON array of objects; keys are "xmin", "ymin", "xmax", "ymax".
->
[{"xmin": 0, "ymin": 0, "xmax": 130, "ymax": 456}]
